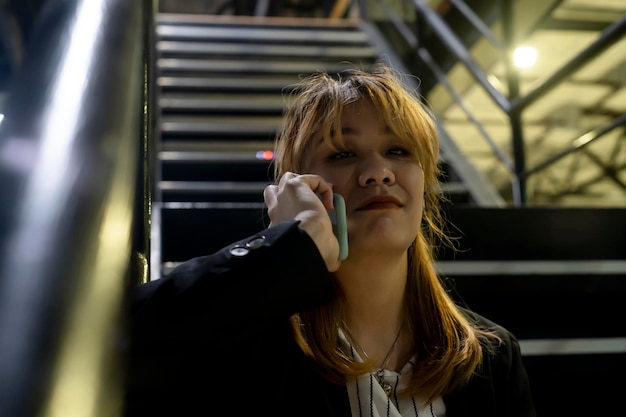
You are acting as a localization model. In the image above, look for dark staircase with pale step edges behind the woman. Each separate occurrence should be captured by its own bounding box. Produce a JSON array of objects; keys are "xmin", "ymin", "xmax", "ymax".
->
[{"xmin": 150, "ymin": 14, "xmax": 626, "ymax": 415}]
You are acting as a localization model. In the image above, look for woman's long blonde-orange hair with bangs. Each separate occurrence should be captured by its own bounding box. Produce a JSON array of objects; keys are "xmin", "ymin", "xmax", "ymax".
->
[{"xmin": 274, "ymin": 63, "xmax": 498, "ymax": 401}]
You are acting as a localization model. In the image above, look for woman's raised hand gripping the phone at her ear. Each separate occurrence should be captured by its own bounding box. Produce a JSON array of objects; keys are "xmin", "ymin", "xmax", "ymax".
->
[{"xmin": 263, "ymin": 172, "xmax": 341, "ymax": 272}]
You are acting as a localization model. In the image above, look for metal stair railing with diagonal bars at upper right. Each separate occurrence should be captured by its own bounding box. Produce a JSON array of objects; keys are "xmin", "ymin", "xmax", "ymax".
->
[{"xmin": 366, "ymin": 0, "xmax": 626, "ymax": 206}]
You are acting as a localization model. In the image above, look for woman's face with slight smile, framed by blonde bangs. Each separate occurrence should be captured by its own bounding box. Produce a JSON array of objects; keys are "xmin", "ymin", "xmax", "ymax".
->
[{"xmin": 305, "ymin": 99, "xmax": 424, "ymax": 256}]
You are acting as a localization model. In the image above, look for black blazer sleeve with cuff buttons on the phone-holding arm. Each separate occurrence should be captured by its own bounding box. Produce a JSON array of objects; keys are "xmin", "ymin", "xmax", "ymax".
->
[{"xmin": 128, "ymin": 221, "xmax": 333, "ymax": 350}]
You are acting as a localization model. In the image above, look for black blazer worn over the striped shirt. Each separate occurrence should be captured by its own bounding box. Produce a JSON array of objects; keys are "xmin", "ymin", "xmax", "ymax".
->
[{"xmin": 124, "ymin": 222, "xmax": 535, "ymax": 417}]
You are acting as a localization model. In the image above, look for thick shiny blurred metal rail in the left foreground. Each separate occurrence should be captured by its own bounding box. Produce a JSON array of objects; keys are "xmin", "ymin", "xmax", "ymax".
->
[{"xmin": 0, "ymin": 0, "xmax": 153, "ymax": 417}]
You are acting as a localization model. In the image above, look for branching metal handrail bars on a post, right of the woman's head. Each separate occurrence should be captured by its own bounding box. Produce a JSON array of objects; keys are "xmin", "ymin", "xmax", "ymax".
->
[{"xmin": 372, "ymin": 0, "xmax": 626, "ymax": 206}]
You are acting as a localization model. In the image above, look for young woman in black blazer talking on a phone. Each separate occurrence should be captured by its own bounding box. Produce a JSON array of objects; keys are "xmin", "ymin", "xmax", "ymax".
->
[{"xmin": 126, "ymin": 65, "xmax": 535, "ymax": 417}]
